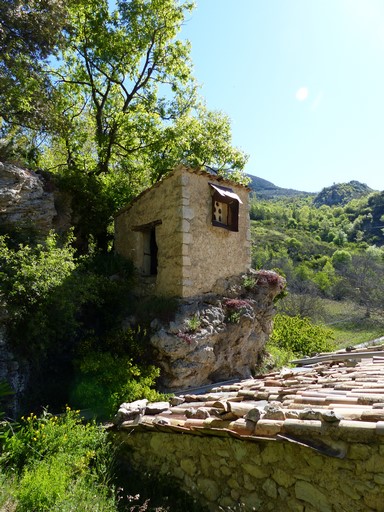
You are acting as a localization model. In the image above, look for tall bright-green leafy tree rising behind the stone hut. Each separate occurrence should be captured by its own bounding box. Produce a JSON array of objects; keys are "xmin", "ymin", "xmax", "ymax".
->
[{"xmin": 40, "ymin": 0, "xmax": 245, "ymax": 247}]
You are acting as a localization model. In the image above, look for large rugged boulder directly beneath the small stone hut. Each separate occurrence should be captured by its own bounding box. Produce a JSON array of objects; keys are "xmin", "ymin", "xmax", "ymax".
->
[{"xmin": 150, "ymin": 270, "xmax": 285, "ymax": 391}]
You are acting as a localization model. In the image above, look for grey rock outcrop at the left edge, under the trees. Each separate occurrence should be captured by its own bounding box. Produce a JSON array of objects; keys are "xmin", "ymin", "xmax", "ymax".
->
[{"xmin": 0, "ymin": 162, "xmax": 56, "ymax": 236}]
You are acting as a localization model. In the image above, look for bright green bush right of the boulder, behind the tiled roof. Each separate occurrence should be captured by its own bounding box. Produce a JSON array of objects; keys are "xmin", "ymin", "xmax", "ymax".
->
[{"xmin": 270, "ymin": 314, "xmax": 334, "ymax": 356}]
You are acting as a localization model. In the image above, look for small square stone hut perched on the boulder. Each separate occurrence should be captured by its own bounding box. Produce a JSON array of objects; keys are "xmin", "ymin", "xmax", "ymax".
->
[{"xmin": 115, "ymin": 166, "xmax": 251, "ymax": 297}]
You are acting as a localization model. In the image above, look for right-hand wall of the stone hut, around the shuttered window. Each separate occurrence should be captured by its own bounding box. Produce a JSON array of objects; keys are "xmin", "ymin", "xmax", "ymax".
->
[{"xmin": 183, "ymin": 173, "xmax": 251, "ymax": 297}]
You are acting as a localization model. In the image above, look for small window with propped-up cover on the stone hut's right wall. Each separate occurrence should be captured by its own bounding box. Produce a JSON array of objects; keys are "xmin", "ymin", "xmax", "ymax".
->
[{"xmin": 209, "ymin": 183, "xmax": 242, "ymax": 231}]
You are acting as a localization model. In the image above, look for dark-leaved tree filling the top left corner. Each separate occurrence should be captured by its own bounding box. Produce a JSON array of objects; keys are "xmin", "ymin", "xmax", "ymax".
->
[{"xmin": 0, "ymin": 0, "xmax": 73, "ymax": 158}]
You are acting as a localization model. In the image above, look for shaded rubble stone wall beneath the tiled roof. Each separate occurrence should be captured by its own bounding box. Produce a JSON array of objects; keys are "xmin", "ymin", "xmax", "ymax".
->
[{"xmin": 116, "ymin": 431, "xmax": 384, "ymax": 512}]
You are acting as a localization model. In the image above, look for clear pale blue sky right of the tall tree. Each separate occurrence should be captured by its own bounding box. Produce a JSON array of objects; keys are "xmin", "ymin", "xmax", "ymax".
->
[{"xmin": 182, "ymin": 0, "xmax": 384, "ymax": 192}]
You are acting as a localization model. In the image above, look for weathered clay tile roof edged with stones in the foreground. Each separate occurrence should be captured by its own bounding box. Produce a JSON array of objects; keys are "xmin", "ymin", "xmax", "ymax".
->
[{"xmin": 117, "ymin": 345, "xmax": 384, "ymax": 456}]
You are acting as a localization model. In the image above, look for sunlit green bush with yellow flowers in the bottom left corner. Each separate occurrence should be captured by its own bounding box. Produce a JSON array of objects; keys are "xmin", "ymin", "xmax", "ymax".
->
[{"xmin": 0, "ymin": 407, "xmax": 117, "ymax": 512}]
